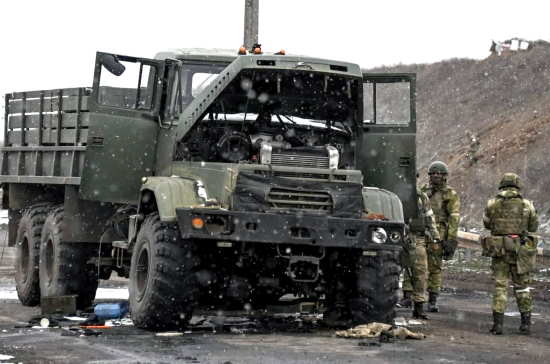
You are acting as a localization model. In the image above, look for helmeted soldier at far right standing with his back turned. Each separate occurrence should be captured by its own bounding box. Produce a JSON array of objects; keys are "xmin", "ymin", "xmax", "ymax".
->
[{"xmin": 482, "ymin": 173, "xmax": 538, "ymax": 335}]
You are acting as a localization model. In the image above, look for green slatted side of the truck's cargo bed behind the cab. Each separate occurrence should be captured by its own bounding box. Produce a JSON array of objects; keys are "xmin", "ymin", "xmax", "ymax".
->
[{"xmin": 0, "ymin": 88, "xmax": 91, "ymax": 184}]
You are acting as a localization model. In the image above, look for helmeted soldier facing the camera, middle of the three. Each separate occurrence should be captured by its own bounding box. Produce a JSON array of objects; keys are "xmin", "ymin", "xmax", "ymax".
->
[{"xmin": 422, "ymin": 161, "xmax": 460, "ymax": 312}]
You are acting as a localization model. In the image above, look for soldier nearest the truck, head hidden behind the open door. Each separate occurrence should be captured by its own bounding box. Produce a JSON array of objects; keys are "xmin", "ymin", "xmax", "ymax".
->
[{"xmin": 401, "ymin": 189, "xmax": 439, "ymax": 319}]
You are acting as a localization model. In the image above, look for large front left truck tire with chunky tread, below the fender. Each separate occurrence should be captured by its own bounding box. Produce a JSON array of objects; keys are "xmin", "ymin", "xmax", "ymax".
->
[{"xmin": 129, "ymin": 213, "xmax": 199, "ymax": 330}]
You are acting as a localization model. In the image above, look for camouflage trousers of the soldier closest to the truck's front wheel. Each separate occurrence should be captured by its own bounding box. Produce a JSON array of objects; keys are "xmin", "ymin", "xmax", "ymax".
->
[{"xmin": 403, "ymin": 235, "xmax": 428, "ymax": 302}]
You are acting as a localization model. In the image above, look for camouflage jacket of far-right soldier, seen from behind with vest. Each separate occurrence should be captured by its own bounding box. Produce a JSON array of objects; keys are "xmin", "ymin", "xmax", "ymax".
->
[{"xmin": 483, "ymin": 187, "xmax": 538, "ymax": 235}]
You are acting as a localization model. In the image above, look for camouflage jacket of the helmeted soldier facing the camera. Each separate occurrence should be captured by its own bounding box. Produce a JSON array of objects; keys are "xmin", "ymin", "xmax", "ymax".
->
[{"xmin": 422, "ymin": 185, "xmax": 460, "ymax": 240}]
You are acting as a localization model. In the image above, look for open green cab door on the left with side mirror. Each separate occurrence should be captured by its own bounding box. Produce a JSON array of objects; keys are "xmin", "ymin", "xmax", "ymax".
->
[{"xmin": 80, "ymin": 52, "xmax": 165, "ymax": 203}]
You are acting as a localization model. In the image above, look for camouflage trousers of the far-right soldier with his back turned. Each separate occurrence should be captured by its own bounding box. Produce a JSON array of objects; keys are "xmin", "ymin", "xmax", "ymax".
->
[{"xmin": 491, "ymin": 257, "xmax": 533, "ymax": 313}]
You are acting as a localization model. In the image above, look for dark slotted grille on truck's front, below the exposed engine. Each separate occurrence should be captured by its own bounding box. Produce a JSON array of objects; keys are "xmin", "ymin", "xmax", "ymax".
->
[{"xmin": 267, "ymin": 188, "xmax": 332, "ymax": 213}]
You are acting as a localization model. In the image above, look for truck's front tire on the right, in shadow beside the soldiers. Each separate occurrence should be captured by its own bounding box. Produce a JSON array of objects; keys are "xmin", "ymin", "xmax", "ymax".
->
[{"xmin": 350, "ymin": 251, "xmax": 401, "ymax": 323}]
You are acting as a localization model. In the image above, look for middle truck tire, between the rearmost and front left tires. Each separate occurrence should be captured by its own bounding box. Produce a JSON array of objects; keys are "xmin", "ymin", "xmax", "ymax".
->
[{"xmin": 39, "ymin": 207, "xmax": 99, "ymax": 309}]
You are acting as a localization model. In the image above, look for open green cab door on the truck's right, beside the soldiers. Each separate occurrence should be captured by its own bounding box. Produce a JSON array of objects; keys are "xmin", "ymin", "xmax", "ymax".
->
[{"xmin": 357, "ymin": 73, "xmax": 417, "ymax": 222}]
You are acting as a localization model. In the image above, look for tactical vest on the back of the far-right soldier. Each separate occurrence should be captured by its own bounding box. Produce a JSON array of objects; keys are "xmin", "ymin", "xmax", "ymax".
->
[{"xmin": 491, "ymin": 196, "xmax": 529, "ymax": 235}]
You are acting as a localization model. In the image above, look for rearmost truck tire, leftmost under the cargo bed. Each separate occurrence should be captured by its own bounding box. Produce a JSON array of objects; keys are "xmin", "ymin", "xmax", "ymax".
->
[{"xmin": 15, "ymin": 204, "xmax": 51, "ymax": 306}]
